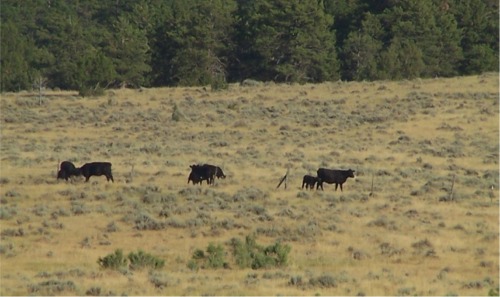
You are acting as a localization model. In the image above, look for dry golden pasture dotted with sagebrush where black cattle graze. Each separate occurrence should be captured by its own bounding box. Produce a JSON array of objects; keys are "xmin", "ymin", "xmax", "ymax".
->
[{"xmin": 0, "ymin": 73, "xmax": 499, "ymax": 296}]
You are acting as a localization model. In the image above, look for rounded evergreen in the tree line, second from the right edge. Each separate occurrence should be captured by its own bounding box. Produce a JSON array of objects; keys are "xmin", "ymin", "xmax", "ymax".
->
[{"xmin": 382, "ymin": 0, "xmax": 462, "ymax": 78}]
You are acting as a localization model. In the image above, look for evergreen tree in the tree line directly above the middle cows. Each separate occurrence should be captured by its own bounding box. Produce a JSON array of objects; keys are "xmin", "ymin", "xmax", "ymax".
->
[{"xmin": 153, "ymin": 0, "xmax": 234, "ymax": 85}]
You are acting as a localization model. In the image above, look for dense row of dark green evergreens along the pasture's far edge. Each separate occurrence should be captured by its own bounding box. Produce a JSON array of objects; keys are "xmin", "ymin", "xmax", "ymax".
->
[{"xmin": 0, "ymin": 0, "xmax": 499, "ymax": 94}]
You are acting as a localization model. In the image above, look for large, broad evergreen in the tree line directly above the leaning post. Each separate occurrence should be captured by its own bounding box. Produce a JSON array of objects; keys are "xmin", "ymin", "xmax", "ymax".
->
[{"xmin": 234, "ymin": 0, "xmax": 339, "ymax": 82}]
